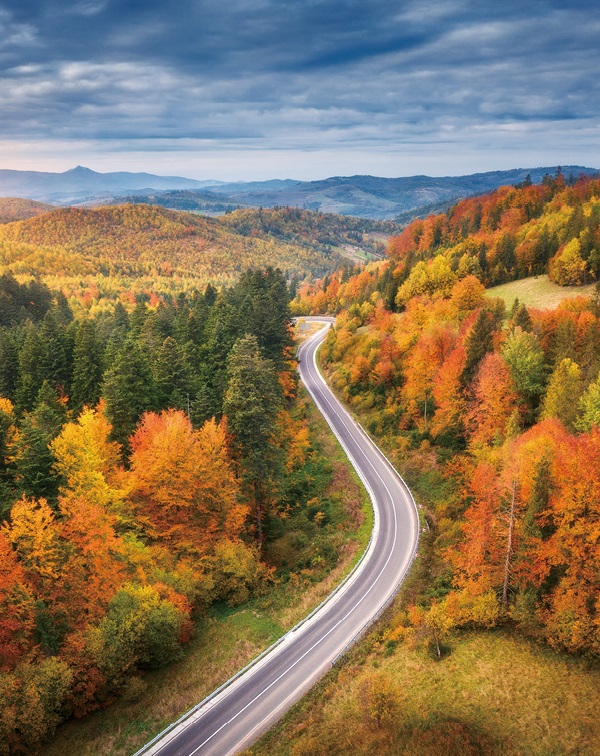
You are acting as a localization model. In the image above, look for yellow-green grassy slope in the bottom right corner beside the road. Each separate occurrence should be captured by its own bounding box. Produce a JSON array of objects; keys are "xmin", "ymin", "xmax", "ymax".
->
[{"xmin": 248, "ymin": 625, "xmax": 600, "ymax": 756}]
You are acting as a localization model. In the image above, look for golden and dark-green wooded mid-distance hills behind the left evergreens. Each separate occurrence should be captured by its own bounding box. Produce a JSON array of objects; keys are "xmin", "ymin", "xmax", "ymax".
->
[{"xmin": 0, "ymin": 198, "xmax": 399, "ymax": 316}]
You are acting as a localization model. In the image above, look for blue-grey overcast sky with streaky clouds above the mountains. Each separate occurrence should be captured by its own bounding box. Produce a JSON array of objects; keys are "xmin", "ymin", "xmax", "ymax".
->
[{"xmin": 0, "ymin": 0, "xmax": 600, "ymax": 180}]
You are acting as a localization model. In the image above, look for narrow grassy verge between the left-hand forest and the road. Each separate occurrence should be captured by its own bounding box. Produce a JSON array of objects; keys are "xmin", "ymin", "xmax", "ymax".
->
[{"xmin": 41, "ymin": 380, "xmax": 372, "ymax": 756}]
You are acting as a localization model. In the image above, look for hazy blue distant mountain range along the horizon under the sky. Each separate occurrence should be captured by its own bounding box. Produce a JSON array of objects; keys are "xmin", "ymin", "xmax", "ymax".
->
[{"xmin": 0, "ymin": 165, "xmax": 598, "ymax": 220}]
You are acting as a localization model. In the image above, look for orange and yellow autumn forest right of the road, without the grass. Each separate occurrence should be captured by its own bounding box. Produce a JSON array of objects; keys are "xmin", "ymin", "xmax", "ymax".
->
[{"xmin": 294, "ymin": 175, "xmax": 600, "ymax": 656}]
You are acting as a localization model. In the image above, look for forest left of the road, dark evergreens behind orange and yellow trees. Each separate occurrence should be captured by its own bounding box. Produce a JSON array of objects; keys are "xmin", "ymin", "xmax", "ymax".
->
[{"xmin": 0, "ymin": 269, "xmax": 360, "ymax": 752}]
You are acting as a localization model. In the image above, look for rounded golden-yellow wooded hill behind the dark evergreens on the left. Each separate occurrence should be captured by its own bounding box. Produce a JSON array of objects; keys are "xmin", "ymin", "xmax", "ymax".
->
[{"xmin": 0, "ymin": 205, "xmax": 340, "ymax": 314}]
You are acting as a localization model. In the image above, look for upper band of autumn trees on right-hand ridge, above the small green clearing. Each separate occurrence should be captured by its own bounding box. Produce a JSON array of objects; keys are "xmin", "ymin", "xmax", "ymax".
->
[{"xmin": 293, "ymin": 173, "xmax": 600, "ymax": 315}]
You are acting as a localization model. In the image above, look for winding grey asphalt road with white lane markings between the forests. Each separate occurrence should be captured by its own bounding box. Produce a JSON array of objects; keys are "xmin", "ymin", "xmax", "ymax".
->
[{"xmin": 135, "ymin": 318, "xmax": 419, "ymax": 756}]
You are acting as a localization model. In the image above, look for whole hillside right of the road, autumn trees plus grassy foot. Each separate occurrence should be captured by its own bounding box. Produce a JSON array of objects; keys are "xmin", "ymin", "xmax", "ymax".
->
[{"xmin": 276, "ymin": 177, "xmax": 600, "ymax": 754}]
